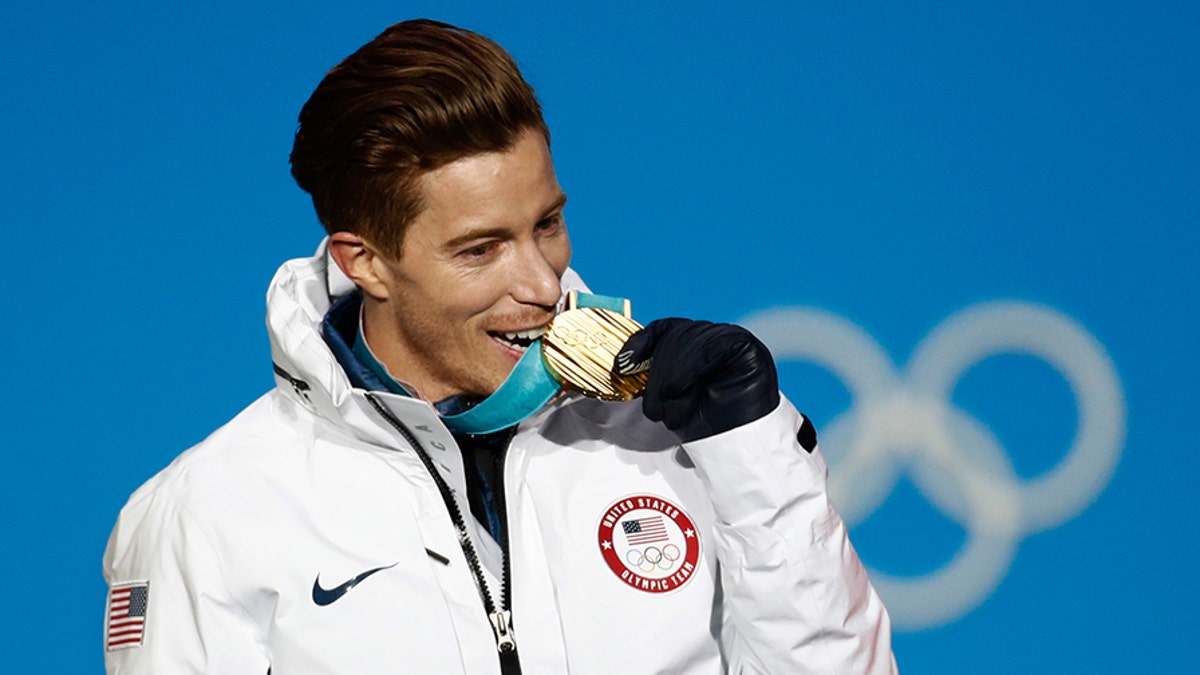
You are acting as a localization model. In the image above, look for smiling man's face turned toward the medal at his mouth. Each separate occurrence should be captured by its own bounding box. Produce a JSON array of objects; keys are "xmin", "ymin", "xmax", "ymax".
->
[{"xmin": 365, "ymin": 126, "xmax": 571, "ymax": 401}]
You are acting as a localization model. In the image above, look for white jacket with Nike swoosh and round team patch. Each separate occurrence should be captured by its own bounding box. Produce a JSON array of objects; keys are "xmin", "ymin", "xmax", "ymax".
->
[{"xmin": 103, "ymin": 242, "xmax": 895, "ymax": 675}]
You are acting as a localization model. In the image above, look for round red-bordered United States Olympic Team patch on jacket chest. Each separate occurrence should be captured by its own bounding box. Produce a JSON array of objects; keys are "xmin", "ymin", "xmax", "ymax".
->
[{"xmin": 600, "ymin": 495, "xmax": 700, "ymax": 593}]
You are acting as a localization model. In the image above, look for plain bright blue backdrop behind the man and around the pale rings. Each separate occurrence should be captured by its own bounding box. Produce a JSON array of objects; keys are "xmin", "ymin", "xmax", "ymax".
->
[{"xmin": 0, "ymin": 0, "xmax": 1200, "ymax": 674}]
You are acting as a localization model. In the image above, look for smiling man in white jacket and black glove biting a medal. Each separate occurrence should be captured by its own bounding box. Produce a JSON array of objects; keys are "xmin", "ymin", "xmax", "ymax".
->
[{"xmin": 104, "ymin": 20, "xmax": 894, "ymax": 675}]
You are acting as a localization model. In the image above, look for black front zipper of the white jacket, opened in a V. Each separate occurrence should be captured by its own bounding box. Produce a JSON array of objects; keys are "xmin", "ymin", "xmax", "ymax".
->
[{"xmin": 366, "ymin": 394, "xmax": 521, "ymax": 675}]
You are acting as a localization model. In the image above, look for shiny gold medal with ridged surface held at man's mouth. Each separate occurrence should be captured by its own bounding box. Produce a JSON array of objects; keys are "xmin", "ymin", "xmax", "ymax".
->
[{"xmin": 541, "ymin": 294, "xmax": 648, "ymax": 401}]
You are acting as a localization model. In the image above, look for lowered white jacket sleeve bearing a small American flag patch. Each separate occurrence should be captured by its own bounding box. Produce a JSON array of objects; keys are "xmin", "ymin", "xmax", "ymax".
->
[{"xmin": 103, "ymin": 486, "xmax": 269, "ymax": 675}]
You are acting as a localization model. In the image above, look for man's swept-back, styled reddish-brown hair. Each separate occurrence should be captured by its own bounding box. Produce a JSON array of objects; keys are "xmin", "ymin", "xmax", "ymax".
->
[{"xmin": 292, "ymin": 19, "xmax": 550, "ymax": 258}]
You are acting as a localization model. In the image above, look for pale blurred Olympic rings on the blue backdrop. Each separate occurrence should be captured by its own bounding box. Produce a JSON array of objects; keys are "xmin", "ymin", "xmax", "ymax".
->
[{"xmin": 742, "ymin": 301, "xmax": 1126, "ymax": 631}]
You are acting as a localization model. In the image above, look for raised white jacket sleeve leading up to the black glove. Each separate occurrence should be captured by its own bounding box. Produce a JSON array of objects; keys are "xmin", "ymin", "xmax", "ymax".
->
[{"xmin": 684, "ymin": 399, "xmax": 896, "ymax": 675}]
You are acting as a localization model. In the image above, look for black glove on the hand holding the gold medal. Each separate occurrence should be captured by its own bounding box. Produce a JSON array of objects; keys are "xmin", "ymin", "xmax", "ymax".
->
[{"xmin": 613, "ymin": 318, "xmax": 779, "ymax": 442}]
